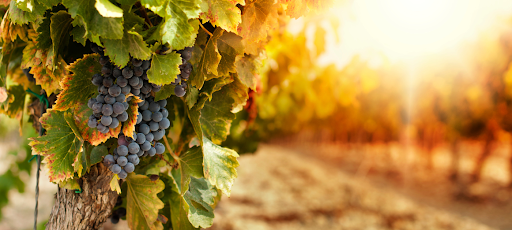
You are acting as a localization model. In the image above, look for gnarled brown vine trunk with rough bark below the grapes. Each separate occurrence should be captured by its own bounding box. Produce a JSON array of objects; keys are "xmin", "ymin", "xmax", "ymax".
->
[{"xmin": 46, "ymin": 163, "xmax": 118, "ymax": 230}]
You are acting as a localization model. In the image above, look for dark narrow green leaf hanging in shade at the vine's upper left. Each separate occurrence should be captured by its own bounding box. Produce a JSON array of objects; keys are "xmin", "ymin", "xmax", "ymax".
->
[{"xmin": 48, "ymin": 11, "xmax": 73, "ymax": 64}]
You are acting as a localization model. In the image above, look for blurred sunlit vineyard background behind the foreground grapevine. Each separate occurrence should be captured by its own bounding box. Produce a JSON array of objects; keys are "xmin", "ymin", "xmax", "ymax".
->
[{"xmin": 5, "ymin": 0, "xmax": 512, "ymax": 230}]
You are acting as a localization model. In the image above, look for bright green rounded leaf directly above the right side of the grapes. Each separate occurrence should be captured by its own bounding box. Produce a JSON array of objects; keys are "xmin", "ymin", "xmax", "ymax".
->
[{"xmin": 148, "ymin": 51, "xmax": 182, "ymax": 85}]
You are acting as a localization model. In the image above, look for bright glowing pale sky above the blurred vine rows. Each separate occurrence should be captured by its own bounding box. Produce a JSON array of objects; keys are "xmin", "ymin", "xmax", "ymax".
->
[{"xmin": 316, "ymin": 0, "xmax": 512, "ymax": 67}]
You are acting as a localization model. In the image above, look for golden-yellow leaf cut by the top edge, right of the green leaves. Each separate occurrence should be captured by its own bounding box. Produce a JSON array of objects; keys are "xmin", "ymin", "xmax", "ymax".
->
[{"xmin": 201, "ymin": 0, "xmax": 245, "ymax": 33}]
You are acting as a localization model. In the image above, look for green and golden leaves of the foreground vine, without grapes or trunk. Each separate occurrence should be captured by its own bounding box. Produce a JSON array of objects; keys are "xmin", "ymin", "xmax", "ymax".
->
[{"xmin": 0, "ymin": 0, "xmax": 326, "ymax": 229}]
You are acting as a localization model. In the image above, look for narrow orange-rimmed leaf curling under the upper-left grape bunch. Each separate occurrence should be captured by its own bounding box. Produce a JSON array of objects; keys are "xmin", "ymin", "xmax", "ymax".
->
[{"xmin": 73, "ymin": 104, "xmax": 121, "ymax": 146}]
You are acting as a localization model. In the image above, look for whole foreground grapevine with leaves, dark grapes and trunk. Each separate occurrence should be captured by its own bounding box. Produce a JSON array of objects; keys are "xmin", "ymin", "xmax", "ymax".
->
[{"xmin": 0, "ymin": 0, "xmax": 327, "ymax": 229}]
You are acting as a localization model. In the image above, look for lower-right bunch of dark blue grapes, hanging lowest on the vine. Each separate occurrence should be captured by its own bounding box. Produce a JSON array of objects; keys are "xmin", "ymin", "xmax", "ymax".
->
[{"xmin": 104, "ymin": 97, "xmax": 171, "ymax": 179}]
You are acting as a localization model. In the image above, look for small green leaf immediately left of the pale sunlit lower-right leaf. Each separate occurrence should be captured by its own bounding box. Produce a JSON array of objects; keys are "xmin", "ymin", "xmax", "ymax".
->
[{"xmin": 171, "ymin": 146, "xmax": 203, "ymax": 195}]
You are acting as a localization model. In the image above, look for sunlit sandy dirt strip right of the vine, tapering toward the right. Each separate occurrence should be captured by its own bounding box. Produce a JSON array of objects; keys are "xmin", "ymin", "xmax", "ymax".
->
[{"xmin": 212, "ymin": 145, "xmax": 493, "ymax": 230}]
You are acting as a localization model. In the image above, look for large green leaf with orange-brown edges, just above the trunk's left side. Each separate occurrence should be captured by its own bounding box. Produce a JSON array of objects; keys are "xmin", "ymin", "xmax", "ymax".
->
[{"xmin": 30, "ymin": 109, "xmax": 83, "ymax": 182}]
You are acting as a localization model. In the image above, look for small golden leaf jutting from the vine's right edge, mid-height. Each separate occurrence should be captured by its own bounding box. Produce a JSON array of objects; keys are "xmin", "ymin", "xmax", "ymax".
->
[{"xmin": 235, "ymin": 55, "xmax": 265, "ymax": 90}]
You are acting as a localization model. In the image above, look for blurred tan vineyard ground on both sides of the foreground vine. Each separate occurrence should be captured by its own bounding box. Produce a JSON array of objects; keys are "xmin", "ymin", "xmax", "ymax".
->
[{"xmin": 0, "ymin": 141, "xmax": 512, "ymax": 230}]
